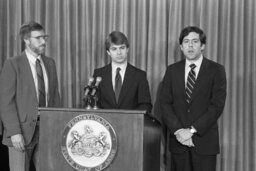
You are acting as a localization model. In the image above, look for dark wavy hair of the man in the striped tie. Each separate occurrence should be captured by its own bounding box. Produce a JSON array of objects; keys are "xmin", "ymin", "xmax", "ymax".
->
[{"xmin": 179, "ymin": 26, "xmax": 206, "ymax": 45}]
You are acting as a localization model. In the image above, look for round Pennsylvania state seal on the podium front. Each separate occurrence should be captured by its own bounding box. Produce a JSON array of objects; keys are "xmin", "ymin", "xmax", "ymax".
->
[{"xmin": 61, "ymin": 114, "xmax": 117, "ymax": 171}]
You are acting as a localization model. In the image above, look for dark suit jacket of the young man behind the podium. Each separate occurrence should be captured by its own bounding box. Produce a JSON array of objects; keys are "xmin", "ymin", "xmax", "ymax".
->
[{"xmin": 93, "ymin": 64, "xmax": 152, "ymax": 112}]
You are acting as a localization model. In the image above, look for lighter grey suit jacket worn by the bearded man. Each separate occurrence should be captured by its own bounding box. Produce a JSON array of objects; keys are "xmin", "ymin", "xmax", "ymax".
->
[{"xmin": 0, "ymin": 52, "xmax": 60, "ymax": 146}]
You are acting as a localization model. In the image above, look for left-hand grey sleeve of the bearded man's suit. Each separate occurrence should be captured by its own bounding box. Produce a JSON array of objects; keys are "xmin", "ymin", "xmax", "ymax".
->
[{"xmin": 0, "ymin": 60, "xmax": 21, "ymax": 137}]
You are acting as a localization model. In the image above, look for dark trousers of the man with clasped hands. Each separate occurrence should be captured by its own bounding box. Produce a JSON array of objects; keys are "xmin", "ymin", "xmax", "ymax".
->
[{"xmin": 171, "ymin": 149, "xmax": 216, "ymax": 171}]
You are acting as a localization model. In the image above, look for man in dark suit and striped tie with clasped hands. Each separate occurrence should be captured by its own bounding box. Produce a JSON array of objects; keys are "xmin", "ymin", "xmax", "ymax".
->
[{"xmin": 160, "ymin": 26, "xmax": 226, "ymax": 171}]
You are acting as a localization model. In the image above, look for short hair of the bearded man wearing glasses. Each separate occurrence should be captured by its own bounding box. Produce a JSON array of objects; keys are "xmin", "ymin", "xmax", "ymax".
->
[{"xmin": 19, "ymin": 21, "xmax": 44, "ymax": 41}]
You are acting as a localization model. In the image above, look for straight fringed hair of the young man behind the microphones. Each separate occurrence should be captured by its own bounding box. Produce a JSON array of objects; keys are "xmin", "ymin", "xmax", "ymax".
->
[{"xmin": 105, "ymin": 31, "xmax": 129, "ymax": 51}]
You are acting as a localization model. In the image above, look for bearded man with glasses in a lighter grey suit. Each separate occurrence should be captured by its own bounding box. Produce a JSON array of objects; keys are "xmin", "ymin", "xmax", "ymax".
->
[{"xmin": 0, "ymin": 21, "xmax": 60, "ymax": 171}]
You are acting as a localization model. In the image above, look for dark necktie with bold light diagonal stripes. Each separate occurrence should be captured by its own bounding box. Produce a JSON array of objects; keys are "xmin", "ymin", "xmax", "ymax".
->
[{"xmin": 186, "ymin": 64, "xmax": 196, "ymax": 103}]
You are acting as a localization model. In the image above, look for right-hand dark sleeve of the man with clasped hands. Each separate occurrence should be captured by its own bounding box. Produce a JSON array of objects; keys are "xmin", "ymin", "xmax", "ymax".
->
[{"xmin": 192, "ymin": 65, "xmax": 227, "ymax": 135}]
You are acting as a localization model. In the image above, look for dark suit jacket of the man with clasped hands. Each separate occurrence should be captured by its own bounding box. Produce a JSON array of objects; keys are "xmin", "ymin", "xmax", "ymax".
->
[{"xmin": 160, "ymin": 58, "xmax": 226, "ymax": 155}]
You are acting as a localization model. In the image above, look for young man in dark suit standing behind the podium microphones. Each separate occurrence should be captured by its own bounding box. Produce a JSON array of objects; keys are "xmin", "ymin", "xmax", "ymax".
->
[{"xmin": 93, "ymin": 31, "xmax": 152, "ymax": 112}]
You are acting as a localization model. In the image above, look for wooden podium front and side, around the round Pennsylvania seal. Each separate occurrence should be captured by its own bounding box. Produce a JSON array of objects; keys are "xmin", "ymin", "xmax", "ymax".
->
[{"xmin": 39, "ymin": 108, "xmax": 161, "ymax": 171}]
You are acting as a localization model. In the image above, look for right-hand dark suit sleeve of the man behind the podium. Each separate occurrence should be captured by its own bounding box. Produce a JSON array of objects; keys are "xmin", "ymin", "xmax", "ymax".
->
[{"xmin": 136, "ymin": 72, "xmax": 152, "ymax": 113}]
